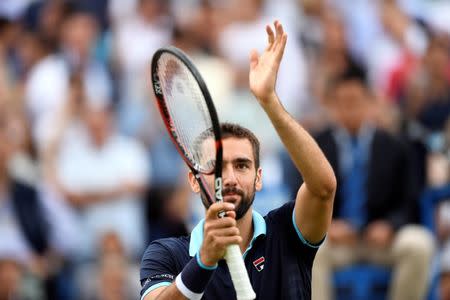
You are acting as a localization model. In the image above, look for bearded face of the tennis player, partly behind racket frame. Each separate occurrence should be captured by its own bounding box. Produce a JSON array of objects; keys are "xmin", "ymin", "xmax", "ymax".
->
[{"xmin": 189, "ymin": 137, "xmax": 262, "ymax": 219}]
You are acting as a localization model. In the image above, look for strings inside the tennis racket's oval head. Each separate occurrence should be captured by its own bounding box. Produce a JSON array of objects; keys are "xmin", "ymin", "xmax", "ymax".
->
[{"xmin": 158, "ymin": 53, "xmax": 215, "ymax": 173}]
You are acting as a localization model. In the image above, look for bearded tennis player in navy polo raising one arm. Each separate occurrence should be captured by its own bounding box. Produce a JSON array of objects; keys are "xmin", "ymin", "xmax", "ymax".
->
[{"xmin": 140, "ymin": 21, "xmax": 336, "ymax": 300}]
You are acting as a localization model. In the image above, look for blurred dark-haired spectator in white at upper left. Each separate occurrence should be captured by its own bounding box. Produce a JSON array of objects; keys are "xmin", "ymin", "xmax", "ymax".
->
[{"xmin": 25, "ymin": 9, "xmax": 112, "ymax": 150}]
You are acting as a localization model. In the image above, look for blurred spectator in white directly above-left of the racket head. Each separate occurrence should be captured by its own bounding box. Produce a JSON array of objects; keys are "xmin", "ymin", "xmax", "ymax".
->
[{"xmin": 114, "ymin": 0, "xmax": 172, "ymax": 138}]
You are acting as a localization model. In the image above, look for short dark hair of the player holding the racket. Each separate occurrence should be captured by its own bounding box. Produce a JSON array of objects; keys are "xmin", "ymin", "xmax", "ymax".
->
[{"xmin": 194, "ymin": 122, "xmax": 260, "ymax": 169}]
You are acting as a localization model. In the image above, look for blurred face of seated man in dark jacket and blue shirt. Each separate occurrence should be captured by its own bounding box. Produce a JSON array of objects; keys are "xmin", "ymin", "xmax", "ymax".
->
[{"xmin": 329, "ymin": 80, "xmax": 369, "ymax": 133}]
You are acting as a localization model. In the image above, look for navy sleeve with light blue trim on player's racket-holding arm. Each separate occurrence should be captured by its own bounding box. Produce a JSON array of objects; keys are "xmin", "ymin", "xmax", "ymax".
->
[{"xmin": 140, "ymin": 241, "xmax": 178, "ymax": 299}]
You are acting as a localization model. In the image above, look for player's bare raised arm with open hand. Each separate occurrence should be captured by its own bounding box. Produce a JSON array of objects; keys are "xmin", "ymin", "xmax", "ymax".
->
[{"xmin": 249, "ymin": 21, "xmax": 336, "ymax": 243}]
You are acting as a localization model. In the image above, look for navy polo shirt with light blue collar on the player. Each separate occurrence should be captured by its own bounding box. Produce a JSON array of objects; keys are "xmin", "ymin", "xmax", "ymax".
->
[{"xmin": 140, "ymin": 202, "xmax": 320, "ymax": 300}]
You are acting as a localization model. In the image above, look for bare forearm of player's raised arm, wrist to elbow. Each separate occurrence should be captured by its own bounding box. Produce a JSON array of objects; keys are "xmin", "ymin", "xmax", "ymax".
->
[{"xmin": 260, "ymin": 94, "xmax": 336, "ymax": 198}]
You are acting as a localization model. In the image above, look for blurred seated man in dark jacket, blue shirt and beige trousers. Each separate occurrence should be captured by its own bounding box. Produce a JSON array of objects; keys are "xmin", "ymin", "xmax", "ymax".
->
[{"xmin": 312, "ymin": 69, "xmax": 434, "ymax": 300}]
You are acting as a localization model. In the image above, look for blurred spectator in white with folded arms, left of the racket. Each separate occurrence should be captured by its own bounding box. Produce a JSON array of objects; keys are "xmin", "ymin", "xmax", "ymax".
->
[{"xmin": 45, "ymin": 74, "xmax": 149, "ymax": 260}]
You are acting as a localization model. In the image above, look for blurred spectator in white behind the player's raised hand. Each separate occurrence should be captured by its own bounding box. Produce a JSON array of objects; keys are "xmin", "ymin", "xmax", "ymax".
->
[{"xmin": 218, "ymin": 0, "xmax": 308, "ymax": 118}]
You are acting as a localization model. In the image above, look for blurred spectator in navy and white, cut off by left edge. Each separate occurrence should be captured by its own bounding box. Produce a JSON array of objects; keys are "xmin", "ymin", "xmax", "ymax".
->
[{"xmin": 0, "ymin": 103, "xmax": 69, "ymax": 299}]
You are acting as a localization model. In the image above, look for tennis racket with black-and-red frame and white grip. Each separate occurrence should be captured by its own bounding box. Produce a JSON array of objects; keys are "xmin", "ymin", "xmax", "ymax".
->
[{"xmin": 151, "ymin": 47, "xmax": 256, "ymax": 300}]
